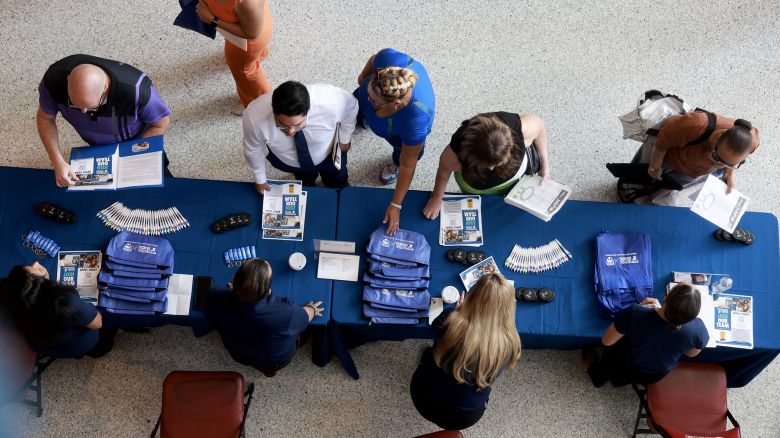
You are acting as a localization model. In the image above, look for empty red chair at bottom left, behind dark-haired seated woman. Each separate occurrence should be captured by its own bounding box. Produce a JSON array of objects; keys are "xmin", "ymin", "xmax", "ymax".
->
[{"xmin": 152, "ymin": 371, "xmax": 255, "ymax": 438}]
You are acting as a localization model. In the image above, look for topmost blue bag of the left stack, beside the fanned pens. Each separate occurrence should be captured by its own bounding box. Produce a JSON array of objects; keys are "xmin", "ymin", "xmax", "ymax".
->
[{"xmin": 106, "ymin": 231, "xmax": 173, "ymax": 270}]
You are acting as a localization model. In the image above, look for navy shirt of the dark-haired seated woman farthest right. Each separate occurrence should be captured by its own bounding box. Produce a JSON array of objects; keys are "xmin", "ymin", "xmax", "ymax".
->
[{"xmin": 614, "ymin": 304, "xmax": 710, "ymax": 374}]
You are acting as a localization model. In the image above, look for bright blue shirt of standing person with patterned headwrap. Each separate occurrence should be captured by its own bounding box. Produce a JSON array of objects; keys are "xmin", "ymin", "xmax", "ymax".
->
[{"xmin": 358, "ymin": 49, "xmax": 436, "ymax": 146}]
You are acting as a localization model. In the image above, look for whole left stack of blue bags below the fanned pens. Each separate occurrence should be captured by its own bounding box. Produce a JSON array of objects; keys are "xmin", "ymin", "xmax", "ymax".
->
[{"xmin": 98, "ymin": 231, "xmax": 173, "ymax": 315}]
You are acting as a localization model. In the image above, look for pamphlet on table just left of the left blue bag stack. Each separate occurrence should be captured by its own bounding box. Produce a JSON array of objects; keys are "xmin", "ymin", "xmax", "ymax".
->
[{"xmin": 57, "ymin": 251, "xmax": 103, "ymax": 304}]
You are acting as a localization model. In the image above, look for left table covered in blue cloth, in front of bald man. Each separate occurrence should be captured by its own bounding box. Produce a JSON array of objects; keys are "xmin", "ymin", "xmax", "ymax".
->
[{"xmin": 0, "ymin": 167, "xmax": 338, "ymax": 365}]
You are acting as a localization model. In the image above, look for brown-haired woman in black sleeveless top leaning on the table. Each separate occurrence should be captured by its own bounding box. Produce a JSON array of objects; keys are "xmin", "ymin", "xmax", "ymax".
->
[{"xmin": 423, "ymin": 111, "xmax": 550, "ymax": 219}]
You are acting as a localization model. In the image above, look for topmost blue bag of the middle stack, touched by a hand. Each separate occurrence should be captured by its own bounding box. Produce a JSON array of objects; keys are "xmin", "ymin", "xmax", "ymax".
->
[{"xmin": 366, "ymin": 225, "xmax": 431, "ymax": 265}]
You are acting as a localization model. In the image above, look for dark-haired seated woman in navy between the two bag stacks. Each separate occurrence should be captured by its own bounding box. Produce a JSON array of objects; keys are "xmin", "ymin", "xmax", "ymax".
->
[{"xmin": 205, "ymin": 259, "xmax": 324, "ymax": 377}]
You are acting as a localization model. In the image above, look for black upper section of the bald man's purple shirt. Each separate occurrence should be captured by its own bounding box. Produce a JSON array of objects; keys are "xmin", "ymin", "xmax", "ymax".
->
[{"xmin": 43, "ymin": 55, "xmax": 152, "ymax": 117}]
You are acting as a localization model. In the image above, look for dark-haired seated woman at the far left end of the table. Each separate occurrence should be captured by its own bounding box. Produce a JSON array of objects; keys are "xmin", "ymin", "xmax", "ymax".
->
[{"xmin": 0, "ymin": 262, "xmax": 116, "ymax": 358}]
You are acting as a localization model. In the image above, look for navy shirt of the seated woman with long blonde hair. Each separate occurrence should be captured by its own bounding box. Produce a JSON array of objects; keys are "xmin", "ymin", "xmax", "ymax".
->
[{"xmin": 415, "ymin": 309, "xmax": 490, "ymax": 411}]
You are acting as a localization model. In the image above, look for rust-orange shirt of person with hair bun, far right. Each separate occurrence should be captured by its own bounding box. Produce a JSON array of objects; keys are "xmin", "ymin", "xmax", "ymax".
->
[{"xmin": 655, "ymin": 111, "xmax": 761, "ymax": 178}]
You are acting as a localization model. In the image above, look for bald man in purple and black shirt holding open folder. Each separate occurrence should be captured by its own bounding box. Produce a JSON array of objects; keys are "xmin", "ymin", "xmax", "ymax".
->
[{"xmin": 36, "ymin": 55, "xmax": 171, "ymax": 187}]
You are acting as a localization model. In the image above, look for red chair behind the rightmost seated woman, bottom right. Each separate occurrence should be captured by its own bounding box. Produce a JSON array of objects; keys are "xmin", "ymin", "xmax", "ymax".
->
[{"xmin": 632, "ymin": 362, "xmax": 742, "ymax": 438}]
